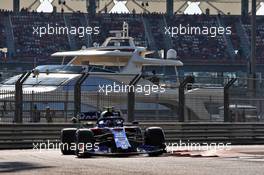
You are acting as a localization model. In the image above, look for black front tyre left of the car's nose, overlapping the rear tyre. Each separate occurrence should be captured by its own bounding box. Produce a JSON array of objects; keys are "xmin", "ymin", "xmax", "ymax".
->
[{"xmin": 75, "ymin": 128, "xmax": 95, "ymax": 158}]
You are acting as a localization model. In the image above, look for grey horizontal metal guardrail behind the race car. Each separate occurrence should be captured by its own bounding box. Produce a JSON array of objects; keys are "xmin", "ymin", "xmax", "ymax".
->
[{"xmin": 0, "ymin": 122, "xmax": 264, "ymax": 149}]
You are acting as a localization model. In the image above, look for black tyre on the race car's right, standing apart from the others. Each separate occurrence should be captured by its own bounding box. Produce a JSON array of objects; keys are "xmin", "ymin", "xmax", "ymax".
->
[{"xmin": 144, "ymin": 127, "xmax": 166, "ymax": 156}]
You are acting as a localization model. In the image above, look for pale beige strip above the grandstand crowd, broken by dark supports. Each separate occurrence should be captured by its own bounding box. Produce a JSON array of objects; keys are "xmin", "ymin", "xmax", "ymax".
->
[{"xmin": 0, "ymin": 0, "xmax": 261, "ymax": 15}]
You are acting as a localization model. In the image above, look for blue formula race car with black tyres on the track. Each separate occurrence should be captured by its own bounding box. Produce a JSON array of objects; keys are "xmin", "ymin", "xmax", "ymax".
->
[{"xmin": 60, "ymin": 108, "xmax": 166, "ymax": 157}]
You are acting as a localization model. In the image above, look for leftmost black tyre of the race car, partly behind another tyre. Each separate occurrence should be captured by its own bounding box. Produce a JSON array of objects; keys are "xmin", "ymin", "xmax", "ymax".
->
[{"xmin": 60, "ymin": 128, "xmax": 77, "ymax": 155}]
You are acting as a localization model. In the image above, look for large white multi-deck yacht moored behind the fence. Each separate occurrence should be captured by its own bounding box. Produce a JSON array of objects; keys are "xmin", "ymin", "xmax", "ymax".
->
[{"xmin": 0, "ymin": 23, "xmax": 223, "ymax": 120}]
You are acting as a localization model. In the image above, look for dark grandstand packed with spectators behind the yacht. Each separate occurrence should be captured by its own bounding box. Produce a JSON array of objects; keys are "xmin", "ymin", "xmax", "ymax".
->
[{"xmin": 0, "ymin": 0, "xmax": 264, "ymax": 74}]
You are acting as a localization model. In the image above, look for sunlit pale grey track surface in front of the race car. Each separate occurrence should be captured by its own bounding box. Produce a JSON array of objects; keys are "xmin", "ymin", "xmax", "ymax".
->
[{"xmin": 0, "ymin": 146, "xmax": 264, "ymax": 175}]
